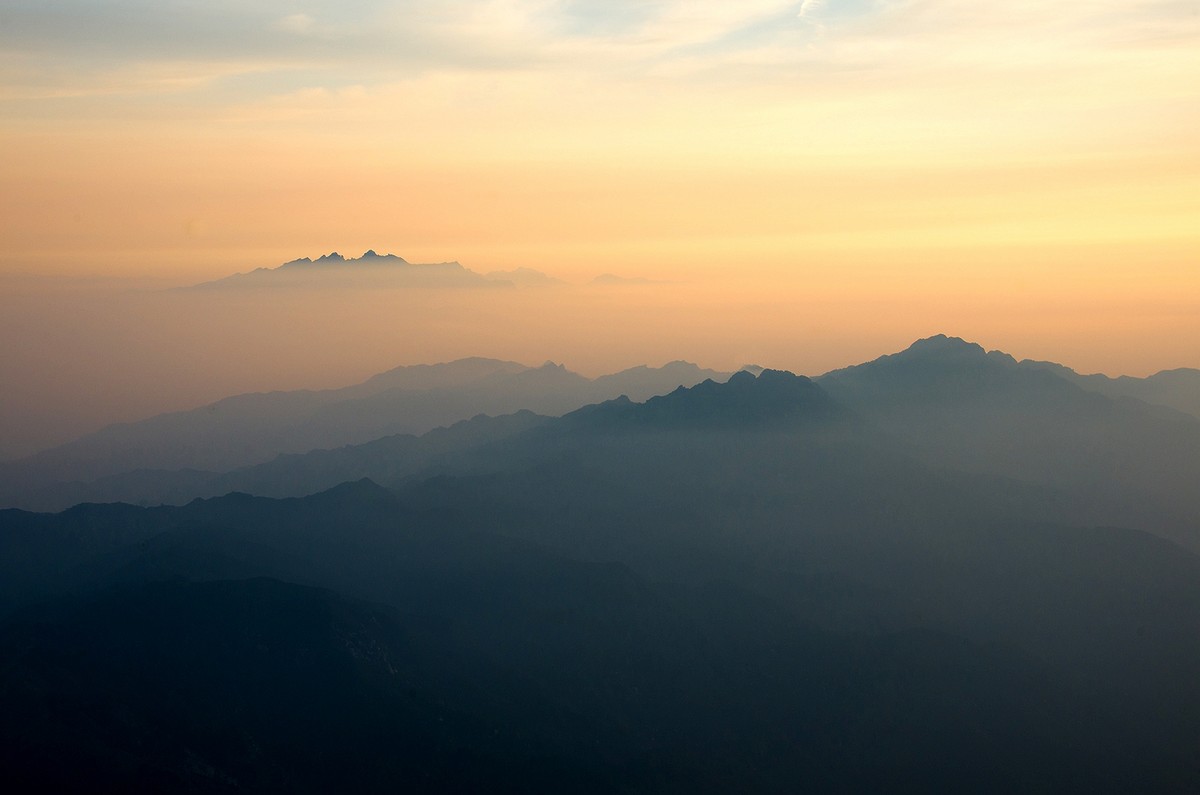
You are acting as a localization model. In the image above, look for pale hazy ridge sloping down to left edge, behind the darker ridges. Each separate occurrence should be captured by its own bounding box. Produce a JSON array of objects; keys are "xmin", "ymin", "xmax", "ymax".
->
[{"xmin": 0, "ymin": 358, "xmax": 727, "ymax": 509}]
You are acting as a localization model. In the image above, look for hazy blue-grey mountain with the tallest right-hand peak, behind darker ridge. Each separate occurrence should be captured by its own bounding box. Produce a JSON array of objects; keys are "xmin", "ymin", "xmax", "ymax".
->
[{"xmin": 817, "ymin": 336, "xmax": 1200, "ymax": 544}]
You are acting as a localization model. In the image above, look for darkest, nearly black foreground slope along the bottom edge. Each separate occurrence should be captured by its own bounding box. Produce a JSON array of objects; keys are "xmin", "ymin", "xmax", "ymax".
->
[{"xmin": 0, "ymin": 580, "xmax": 1153, "ymax": 793}]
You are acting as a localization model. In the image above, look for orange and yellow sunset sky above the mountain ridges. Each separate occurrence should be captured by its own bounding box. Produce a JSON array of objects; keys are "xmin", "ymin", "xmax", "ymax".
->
[{"xmin": 0, "ymin": 0, "xmax": 1200, "ymax": 458}]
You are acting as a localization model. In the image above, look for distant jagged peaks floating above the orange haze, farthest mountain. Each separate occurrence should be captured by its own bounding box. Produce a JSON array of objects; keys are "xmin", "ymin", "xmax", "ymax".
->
[{"xmin": 187, "ymin": 249, "xmax": 558, "ymax": 291}]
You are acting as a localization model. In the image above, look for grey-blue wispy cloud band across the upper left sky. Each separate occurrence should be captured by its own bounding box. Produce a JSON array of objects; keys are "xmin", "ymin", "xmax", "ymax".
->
[{"xmin": 0, "ymin": 0, "xmax": 825, "ymax": 94}]
